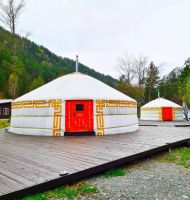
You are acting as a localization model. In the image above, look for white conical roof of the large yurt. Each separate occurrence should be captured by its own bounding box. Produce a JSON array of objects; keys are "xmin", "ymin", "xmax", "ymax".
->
[{"xmin": 14, "ymin": 72, "xmax": 135, "ymax": 101}]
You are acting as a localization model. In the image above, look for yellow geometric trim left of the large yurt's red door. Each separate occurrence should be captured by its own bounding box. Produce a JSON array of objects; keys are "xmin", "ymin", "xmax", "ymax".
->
[{"xmin": 12, "ymin": 99, "xmax": 62, "ymax": 136}]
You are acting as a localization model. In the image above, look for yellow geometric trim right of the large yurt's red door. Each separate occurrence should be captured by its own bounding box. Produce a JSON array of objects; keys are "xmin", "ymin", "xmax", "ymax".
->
[{"xmin": 96, "ymin": 100, "xmax": 137, "ymax": 136}]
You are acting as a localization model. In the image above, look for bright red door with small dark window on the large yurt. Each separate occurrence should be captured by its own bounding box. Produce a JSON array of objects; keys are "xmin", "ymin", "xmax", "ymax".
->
[{"xmin": 65, "ymin": 100, "xmax": 94, "ymax": 132}]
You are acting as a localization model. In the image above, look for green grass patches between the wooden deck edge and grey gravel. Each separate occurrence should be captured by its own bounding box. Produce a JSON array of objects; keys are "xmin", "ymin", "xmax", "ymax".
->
[{"xmin": 18, "ymin": 147, "xmax": 190, "ymax": 200}]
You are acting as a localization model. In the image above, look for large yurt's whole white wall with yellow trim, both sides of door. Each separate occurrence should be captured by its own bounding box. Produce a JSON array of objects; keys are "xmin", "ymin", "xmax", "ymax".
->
[{"xmin": 10, "ymin": 100, "xmax": 138, "ymax": 136}]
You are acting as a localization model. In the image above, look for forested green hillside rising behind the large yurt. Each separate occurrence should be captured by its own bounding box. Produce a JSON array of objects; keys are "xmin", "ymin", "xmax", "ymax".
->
[{"xmin": 0, "ymin": 27, "xmax": 117, "ymax": 98}]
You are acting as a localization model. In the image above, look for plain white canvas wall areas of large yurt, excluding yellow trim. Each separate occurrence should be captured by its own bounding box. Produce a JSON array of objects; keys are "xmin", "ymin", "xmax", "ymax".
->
[{"xmin": 9, "ymin": 101, "xmax": 138, "ymax": 136}]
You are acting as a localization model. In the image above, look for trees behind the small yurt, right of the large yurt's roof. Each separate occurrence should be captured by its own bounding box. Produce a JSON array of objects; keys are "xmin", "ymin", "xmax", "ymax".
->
[{"xmin": 116, "ymin": 53, "xmax": 190, "ymax": 106}]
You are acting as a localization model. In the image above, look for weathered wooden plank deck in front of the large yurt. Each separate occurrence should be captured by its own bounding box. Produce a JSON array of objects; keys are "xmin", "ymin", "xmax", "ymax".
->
[{"xmin": 0, "ymin": 127, "xmax": 190, "ymax": 200}]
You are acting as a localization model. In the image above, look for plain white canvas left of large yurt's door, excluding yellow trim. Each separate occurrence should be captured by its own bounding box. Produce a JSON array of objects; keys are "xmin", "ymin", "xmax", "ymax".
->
[{"xmin": 9, "ymin": 101, "xmax": 65, "ymax": 136}]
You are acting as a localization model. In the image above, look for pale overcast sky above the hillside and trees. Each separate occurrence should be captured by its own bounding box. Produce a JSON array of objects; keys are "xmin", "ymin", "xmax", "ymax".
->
[{"xmin": 13, "ymin": 0, "xmax": 190, "ymax": 78}]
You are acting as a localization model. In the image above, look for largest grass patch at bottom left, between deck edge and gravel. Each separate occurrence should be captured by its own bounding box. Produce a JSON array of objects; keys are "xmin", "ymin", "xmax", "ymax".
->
[{"xmin": 23, "ymin": 182, "xmax": 97, "ymax": 200}]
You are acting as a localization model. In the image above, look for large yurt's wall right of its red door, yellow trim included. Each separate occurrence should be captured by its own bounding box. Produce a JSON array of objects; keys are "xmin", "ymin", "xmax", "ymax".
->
[{"xmin": 95, "ymin": 100, "xmax": 138, "ymax": 135}]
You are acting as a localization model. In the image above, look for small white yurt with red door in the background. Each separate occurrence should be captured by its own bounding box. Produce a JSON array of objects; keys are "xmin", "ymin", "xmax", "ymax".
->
[{"xmin": 140, "ymin": 98, "xmax": 183, "ymax": 121}]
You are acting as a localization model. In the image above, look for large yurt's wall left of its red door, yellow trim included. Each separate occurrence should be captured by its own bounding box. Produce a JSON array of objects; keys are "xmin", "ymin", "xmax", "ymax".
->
[{"xmin": 10, "ymin": 100, "xmax": 65, "ymax": 136}]
